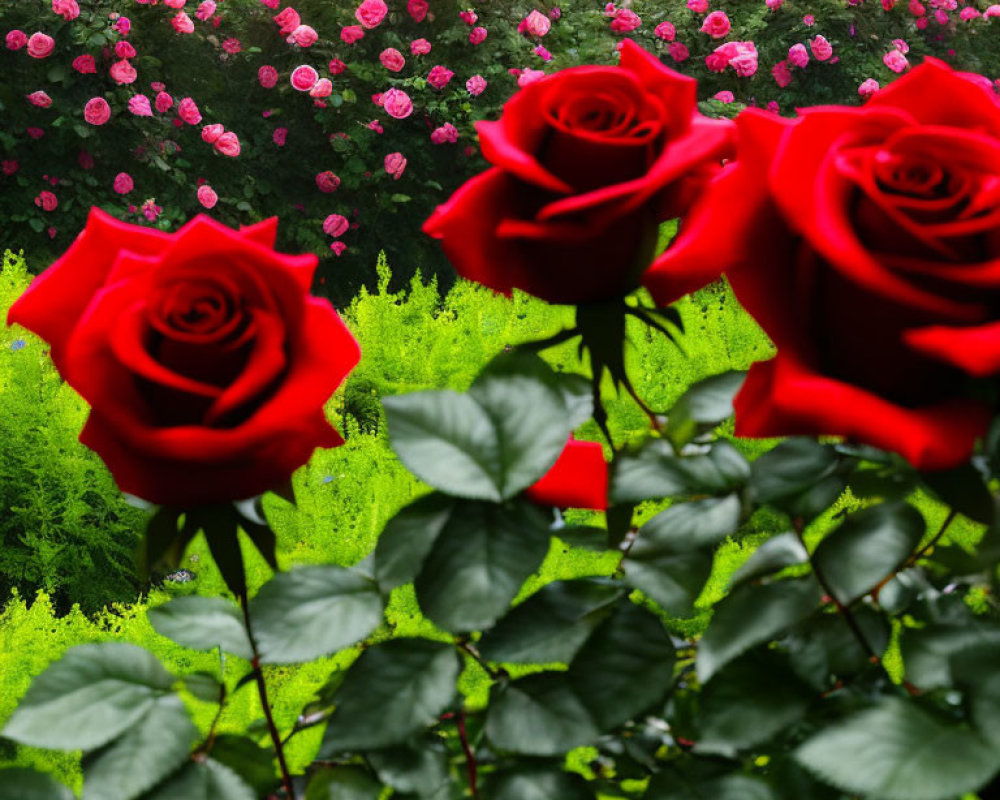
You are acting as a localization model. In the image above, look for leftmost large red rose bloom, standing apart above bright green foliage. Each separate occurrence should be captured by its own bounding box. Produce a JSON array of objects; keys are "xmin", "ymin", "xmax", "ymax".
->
[{"xmin": 7, "ymin": 208, "xmax": 359, "ymax": 506}]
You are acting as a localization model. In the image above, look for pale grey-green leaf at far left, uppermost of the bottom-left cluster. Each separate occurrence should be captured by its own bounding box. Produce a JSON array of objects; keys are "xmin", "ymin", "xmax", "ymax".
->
[{"xmin": 3, "ymin": 642, "xmax": 174, "ymax": 750}]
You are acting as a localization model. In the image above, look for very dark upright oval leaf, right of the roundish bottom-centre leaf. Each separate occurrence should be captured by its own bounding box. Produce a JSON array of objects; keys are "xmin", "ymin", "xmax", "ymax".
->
[{"xmin": 569, "ymin": 600, "xmax": 675, "ymax": 731}]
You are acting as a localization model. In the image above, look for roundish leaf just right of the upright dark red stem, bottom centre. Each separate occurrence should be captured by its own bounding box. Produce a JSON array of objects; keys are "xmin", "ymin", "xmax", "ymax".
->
[{"xmin": 486, "ymin": 672, "xmax": 599, "ymax": 756}]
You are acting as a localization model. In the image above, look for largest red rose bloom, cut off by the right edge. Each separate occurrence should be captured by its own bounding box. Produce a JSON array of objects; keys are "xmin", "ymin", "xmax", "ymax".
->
[{"xmin": 644, "ymin": 60, "xmax": 1000, "ymax": 469}]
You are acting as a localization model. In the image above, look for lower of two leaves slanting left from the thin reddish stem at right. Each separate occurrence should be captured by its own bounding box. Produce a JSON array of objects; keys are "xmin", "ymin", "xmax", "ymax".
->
[{"xmin": 698, "ymin": 578, "xmax": 820, "ymax": 683}]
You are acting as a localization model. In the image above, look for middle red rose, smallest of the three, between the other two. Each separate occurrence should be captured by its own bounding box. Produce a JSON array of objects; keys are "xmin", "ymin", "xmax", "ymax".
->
[{"xmin": 424, "ymin": 41, "xmax": 733, "ymax": 303}]
